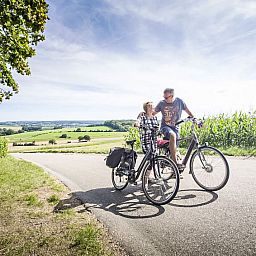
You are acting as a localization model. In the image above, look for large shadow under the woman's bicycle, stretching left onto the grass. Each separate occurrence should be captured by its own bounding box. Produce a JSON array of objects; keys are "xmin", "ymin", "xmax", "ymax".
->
[{"xmin": 54, "ymin": 186, "xmax": 165, "ymax": 219}]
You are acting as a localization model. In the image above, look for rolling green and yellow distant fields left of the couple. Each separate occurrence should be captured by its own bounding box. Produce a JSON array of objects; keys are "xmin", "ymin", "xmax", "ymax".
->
[{"xmin": 5, "ymin": 126, "xmax": 126, "ymax": 153}]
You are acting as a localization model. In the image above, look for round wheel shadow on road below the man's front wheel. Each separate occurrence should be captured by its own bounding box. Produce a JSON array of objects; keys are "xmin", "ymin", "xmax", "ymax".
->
[{"xmin": 169, "ymin": 189, "xmax": 218, "ymax": 207}]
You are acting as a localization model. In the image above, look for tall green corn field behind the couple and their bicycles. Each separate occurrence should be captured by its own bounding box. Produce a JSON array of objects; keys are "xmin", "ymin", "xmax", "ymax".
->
[{"xmin": 125, "ymin": 111, "xmax": 256, "ymax": 148}]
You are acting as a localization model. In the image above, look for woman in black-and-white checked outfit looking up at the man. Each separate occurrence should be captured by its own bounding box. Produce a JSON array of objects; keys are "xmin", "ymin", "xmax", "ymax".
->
[{"xmin": 135, "ymin": 101, "xmax": 159, "ymax": 154}]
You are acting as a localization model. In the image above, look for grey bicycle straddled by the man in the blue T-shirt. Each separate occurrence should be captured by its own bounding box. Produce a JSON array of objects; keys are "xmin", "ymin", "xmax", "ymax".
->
[{"xmin": 158, "ymin": 117, "xmax": 230, "ymax": 191}]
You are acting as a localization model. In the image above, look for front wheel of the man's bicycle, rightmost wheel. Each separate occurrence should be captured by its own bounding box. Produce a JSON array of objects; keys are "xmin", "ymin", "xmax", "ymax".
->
[{"xmin": 190, "ymin": 146, "xmax": 229, "ymax": 191}]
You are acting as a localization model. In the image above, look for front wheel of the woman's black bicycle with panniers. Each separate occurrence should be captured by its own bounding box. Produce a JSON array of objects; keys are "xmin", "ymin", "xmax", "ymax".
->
[{"xmin": 142, "ymin": 156, "xmax": 180, "ymax": 205}]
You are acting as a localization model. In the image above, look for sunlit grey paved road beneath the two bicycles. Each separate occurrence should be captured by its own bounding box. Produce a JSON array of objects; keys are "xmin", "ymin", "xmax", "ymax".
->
[{"xmin": 14, "ymin": 153, "xmax": 256, "ymax": 256}]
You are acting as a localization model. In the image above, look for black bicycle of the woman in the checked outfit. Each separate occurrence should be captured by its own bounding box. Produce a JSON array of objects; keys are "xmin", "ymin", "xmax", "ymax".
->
[{"xmin": 107, "ymin": 128, "xmax": 180, "ymax": 205}]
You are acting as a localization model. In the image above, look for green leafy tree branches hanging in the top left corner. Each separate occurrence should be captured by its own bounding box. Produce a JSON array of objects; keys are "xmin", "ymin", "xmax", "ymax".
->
[{"xmin": 0, "ymin": 0, "xmax": 49, "ymax": 102}]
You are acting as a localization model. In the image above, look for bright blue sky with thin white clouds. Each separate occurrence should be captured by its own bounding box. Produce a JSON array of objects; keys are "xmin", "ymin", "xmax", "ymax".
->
[{"xmin": 0, "ymin": 0, "xmax": 256, "ymax": 121}]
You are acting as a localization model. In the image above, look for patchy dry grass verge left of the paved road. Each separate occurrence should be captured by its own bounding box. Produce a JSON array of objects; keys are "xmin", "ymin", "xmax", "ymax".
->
[{"xmin": 0, "ymin": 156, "xmax": 124, "ymax": 256}]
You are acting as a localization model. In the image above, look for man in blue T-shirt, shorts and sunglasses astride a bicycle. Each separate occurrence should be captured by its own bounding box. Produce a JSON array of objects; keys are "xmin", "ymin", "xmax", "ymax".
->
[{"xmin": 154, "ymin": 88, "xmax": 193, "ymax": 168}]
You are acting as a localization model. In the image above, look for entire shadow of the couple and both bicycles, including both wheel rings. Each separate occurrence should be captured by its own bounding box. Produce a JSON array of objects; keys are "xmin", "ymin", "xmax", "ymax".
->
[{"xmin": 54, "ymin": 186, "xmax": 218, "ymax": 219}]
